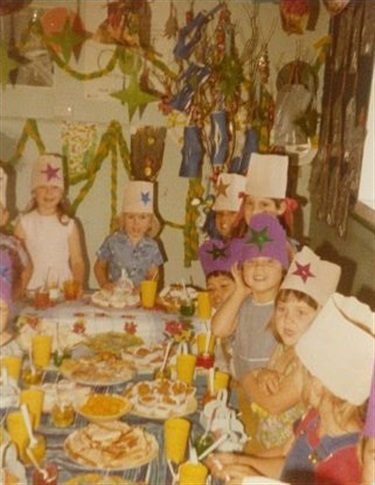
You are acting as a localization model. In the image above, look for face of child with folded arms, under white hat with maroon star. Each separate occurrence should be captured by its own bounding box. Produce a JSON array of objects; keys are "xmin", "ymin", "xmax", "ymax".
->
[{"xmin": 275, "ymin": 296, "xmax": 317, "ymax": 347}]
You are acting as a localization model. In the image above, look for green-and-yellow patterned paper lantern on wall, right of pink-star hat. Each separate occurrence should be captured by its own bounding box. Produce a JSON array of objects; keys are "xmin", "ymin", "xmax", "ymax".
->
[{"xmin": 61, "ymin": 122, "xmax": 98, "ymax": 184}]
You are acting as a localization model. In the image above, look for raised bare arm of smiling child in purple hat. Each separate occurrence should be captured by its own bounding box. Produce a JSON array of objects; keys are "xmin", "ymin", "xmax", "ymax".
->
[{"xmin": 211, "ymin": 263, "xmax": 251, "ymax": 338}]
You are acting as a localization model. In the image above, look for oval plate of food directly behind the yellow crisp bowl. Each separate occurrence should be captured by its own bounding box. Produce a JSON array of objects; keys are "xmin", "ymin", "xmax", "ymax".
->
[{"xmin": 59, "ymin": 353, "xmax": 135, "ymax": 386}]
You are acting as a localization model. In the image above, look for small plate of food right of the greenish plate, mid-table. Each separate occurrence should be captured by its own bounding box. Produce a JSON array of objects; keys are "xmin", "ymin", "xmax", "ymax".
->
[{"xmin": 121, "ymin": 344, "xmax": 175, "ymax": 372}]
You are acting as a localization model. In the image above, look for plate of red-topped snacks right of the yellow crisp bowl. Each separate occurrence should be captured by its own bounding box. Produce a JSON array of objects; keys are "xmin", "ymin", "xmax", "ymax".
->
[{"xmin": 124, "ymin": 379, "xmax": 198, "ymax": 420}]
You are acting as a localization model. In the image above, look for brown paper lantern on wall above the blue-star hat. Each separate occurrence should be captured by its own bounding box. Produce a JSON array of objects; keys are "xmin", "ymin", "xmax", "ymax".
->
[{"xmin": 130, "ymin": 126, "xmax": 167, "ymax": 182}]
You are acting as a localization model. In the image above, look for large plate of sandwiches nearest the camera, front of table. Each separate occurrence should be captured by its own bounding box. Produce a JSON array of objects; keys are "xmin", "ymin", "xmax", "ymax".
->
[{"xmin": 64, "ymin": 420, "xmax": 159, "ymax": 471}]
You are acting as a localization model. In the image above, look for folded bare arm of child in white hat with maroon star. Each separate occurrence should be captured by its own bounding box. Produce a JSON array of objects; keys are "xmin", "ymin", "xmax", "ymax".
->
[{"xmin": 241, "ymin": 366, "xmax": 302, "ymax": 414}]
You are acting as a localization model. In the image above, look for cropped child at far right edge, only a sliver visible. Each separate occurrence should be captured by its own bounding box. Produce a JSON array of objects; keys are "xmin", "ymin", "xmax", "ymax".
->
[{"xmin": 361, "ymin": 360, "xmax": 375, "ymax": 485}]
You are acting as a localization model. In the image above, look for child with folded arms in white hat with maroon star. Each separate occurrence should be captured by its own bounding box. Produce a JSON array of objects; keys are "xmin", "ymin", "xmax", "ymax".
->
[{"xmin": 241, "ymin": 246, "xmax": 341, "ymax": 454}]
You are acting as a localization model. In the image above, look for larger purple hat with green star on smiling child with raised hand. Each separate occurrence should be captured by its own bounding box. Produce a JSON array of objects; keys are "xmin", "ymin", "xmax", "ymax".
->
[{"xmin": 241, "ymin": 212, "xmax": 289, "ymax": 269}]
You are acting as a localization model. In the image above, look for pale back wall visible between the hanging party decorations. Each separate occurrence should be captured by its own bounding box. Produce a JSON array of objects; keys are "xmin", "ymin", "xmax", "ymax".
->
[{"xmin": 0, "ymin": 0, "xmax": 328, "ymax": 287}]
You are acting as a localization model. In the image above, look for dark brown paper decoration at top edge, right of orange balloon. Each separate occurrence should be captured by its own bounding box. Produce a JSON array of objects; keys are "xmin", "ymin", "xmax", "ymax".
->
[{"xmin": 94, "ymin": 0, "xmax": 151, "ymax": 49}]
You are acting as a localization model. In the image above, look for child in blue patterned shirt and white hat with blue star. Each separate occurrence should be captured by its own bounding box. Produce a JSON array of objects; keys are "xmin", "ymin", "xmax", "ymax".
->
[{"xmin": 94, "ymin": 181, "xmax": 164, "ymax": 290}]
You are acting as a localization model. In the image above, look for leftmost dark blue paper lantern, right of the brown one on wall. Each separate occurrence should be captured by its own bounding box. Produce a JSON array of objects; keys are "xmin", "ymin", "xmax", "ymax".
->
[{"xmin": 179, "ymin": 126, "xmax": 204, "ymax": 178}]
